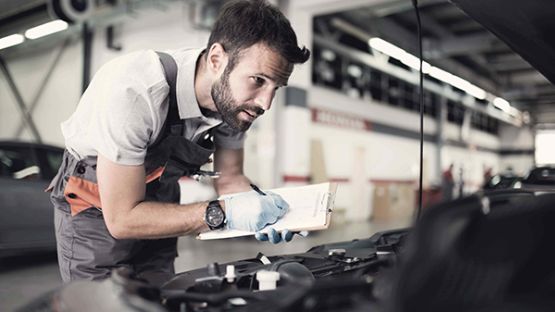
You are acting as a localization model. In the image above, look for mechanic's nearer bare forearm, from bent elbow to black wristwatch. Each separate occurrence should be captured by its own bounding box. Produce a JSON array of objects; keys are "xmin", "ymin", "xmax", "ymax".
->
[{"xmin": 107, "ymin": 202, "xmax": 218, "ymax": 239}]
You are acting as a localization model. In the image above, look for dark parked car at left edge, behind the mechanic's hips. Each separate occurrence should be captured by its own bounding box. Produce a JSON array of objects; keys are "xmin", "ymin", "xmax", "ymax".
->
[{"xmin": 0, "ymin": 141, "xmax": 63, "ymax": 257}]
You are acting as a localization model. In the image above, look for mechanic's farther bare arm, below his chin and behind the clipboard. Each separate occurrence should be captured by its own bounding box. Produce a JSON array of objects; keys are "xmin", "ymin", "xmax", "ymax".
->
[{"xmin": 214, "ymin": 148, "xmax": 251, "ymax": 195}]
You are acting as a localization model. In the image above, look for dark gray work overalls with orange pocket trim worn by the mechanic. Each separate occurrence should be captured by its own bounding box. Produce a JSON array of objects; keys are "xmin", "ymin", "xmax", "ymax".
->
[{"xmin": 49, "ymin": 53, "xmax": 214, "ymax": 285}]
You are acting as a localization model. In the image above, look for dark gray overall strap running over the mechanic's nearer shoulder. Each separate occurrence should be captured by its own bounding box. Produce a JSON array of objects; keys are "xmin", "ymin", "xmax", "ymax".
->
[{"xmin": 152, "ymin": 51, "xmax": 183, "ymax": 146}]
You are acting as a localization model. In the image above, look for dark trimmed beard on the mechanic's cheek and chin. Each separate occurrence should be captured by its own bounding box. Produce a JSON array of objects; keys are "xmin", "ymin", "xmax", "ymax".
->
[{"xmin": 210, "ymin": 68, "xmax": 264, "ymax": 131}]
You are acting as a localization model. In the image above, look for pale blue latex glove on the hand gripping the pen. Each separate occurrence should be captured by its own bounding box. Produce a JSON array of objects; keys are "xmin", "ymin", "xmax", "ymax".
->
[{"xmin": 224, "ymin": 191, "xmax": 289, "ymax": 232}]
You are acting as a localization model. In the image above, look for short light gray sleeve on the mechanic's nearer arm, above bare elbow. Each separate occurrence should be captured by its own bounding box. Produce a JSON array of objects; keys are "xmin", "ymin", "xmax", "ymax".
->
[{"xmin": 84, "ymin": 59, "xmax": 163, "ymax": 165}]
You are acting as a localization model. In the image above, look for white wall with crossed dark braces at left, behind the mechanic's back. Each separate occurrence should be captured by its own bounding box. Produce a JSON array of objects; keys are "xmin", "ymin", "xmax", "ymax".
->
[{"xmin": 0, "ymin": 43, "xmax": 82, "ymax": 145}]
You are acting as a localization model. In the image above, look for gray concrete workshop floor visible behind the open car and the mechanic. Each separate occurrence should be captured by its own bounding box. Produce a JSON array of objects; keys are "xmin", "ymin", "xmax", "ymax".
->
[{"xmin": 0, "ymin": 221, "xmax": 408, "ymax": 311}]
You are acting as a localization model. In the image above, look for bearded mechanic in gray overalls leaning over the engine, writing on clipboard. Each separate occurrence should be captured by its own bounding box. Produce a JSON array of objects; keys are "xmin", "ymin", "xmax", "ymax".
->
[{"xmin": 51, "ymin": 0, "xmax": 310, "ymax": 284}]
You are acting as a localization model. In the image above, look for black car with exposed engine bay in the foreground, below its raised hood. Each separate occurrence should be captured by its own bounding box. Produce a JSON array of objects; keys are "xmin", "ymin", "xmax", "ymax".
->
[{"xmin": 21, "ymin": 190, "xmax": 555, "ymax": 312}]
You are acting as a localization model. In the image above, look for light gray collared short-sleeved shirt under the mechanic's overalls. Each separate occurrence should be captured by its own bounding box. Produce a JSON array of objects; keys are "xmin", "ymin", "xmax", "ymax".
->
[{"xmin": 61, "ymin": 49, "xmax": 245, "ymax": 165}]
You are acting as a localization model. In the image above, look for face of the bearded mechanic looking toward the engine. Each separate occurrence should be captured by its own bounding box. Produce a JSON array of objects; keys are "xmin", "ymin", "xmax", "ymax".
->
[{"xmin": 211, "ymin": 44, "xmax": 293, "ymax": 131}]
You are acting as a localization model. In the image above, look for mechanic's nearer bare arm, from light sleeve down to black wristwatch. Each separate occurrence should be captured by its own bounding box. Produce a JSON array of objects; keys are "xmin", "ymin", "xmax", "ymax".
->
[{"xmin": 97, "ymin": 155, "xmax": 212, "ymax": 239}]
